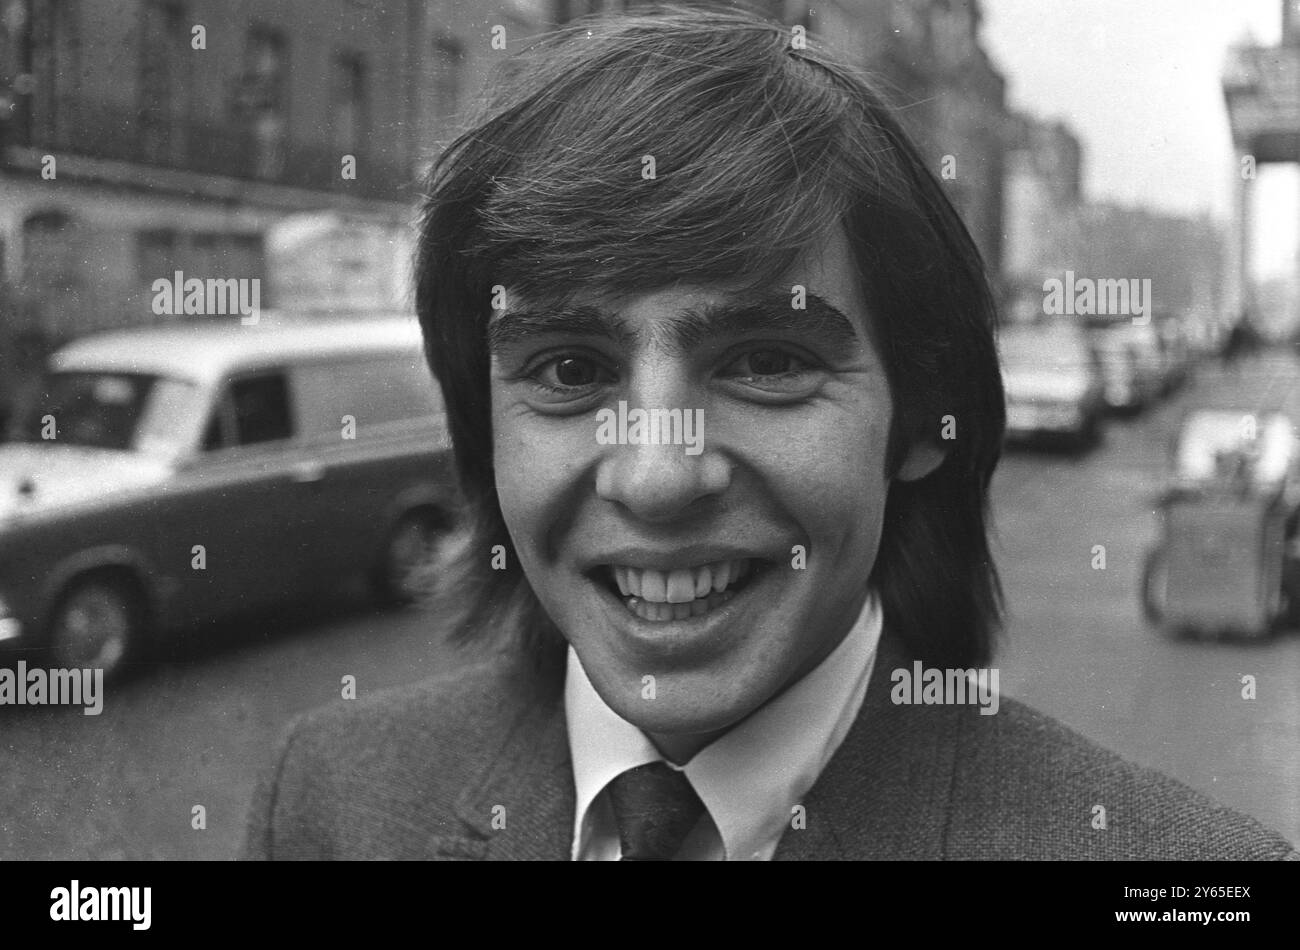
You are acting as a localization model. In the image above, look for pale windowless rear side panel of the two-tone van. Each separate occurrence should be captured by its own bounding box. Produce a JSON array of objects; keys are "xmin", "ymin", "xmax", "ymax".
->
[{"xmin": 294, "ymin": 350, "xmax": 442, "ymax": 439}]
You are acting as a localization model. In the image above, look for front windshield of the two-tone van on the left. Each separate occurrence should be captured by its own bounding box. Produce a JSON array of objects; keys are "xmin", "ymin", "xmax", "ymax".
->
[{"xmin": 13, "ymin": 370, "xmax": 199, "ymax": 455}]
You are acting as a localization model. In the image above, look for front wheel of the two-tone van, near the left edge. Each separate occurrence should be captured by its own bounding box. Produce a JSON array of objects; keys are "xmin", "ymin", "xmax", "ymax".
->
[{"xmin": 49, "ymin": 580, "xmax": 142, "ymax": 677}]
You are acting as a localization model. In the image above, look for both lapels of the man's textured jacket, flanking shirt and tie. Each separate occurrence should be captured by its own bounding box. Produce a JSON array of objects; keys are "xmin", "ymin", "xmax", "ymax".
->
[{"xmin": 429, "ymin": 633, "xmax": 961, "ymax": 860}]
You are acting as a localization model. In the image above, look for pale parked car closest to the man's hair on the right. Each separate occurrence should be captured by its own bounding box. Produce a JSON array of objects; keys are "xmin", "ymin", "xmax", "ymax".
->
[{"xmin": 998, "ymin": 324, "xmax": 1105, "ymax": 447}]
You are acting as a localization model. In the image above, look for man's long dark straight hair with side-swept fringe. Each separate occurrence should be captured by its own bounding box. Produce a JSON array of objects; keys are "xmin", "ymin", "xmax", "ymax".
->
[{"xmin": 416, "ymin": 9, "xmax": 1005, "ymax": 667}]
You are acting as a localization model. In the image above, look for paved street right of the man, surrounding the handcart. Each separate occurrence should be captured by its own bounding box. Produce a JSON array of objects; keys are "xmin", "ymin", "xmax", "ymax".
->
[{"xmin": 995, "ymin": 355, "xmax": 1300, "ymax": 841}]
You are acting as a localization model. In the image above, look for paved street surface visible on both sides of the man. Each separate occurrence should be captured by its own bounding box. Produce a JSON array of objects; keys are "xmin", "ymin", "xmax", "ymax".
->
[{"xmin": 0, "ymin": 355, "xmax": 1300, "ymax": 859}]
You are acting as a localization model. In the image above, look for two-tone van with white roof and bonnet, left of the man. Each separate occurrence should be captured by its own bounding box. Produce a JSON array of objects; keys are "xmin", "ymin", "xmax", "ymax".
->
[{"xmin": 0, "ymin": 315, "xmax": 458, "ymax": 674}]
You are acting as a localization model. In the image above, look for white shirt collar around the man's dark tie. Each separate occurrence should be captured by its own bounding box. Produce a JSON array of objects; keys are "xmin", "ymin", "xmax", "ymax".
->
[{"xmin": 564, "ymin": 591, "xmax": 881, "ymax": 860}]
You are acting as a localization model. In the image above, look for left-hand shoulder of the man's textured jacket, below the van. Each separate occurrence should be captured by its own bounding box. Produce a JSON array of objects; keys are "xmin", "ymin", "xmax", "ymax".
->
[{"xmin": 241, "ymin": 659, "xmax": 555, "ymax": 860}]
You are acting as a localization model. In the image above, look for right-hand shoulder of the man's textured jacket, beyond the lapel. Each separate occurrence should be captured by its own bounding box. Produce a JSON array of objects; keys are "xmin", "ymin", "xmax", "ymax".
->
[{"xmin": 946, "ymin": 698, "xmax": 1300, "ymax": 860}]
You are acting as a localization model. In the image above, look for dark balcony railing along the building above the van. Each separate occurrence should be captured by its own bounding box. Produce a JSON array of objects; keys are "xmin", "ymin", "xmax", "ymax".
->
[{"xmin": 8, "ymin": 99, "xmax": 415, "ymax": 200}]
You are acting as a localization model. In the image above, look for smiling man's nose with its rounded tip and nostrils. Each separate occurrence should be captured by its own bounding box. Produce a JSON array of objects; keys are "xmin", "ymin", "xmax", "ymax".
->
[{"xmin": 595, "ymin": 413, "xmax": 732, "ymax": 521}]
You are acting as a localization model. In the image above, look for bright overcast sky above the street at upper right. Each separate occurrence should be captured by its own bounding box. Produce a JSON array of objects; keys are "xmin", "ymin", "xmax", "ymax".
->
[{"xmin": 982, "ymin": 0, "xmax": 1300, "ymax": 269}]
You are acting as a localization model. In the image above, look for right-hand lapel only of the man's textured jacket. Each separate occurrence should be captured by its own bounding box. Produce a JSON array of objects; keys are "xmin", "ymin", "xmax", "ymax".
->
[{"xmin": 775, "ymin": 633, "xmax": 961, "ymax": 860}]
